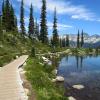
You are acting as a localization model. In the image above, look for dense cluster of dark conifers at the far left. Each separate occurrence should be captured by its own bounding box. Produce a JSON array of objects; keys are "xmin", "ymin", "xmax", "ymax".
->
[{"xmin": 0, "ymin": 0, "xmax": 18, "ymax": 32}]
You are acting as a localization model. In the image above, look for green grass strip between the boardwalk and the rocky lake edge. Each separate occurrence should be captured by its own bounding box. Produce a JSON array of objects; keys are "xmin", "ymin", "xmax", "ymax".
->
[{"xmin": 25, "ymin": 57, "xmax": 67, "ymax": 100}]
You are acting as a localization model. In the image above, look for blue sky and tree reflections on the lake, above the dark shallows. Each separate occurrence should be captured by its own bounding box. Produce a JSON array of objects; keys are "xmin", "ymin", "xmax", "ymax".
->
[{"xmin": 58, "ymin": 56, "xmax": 100, "ymax": 83}]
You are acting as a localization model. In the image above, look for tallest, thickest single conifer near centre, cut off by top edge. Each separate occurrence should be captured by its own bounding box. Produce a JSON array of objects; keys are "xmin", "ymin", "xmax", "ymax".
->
[{"xmin": 40, "ymin": 0, "xmax": 48, "ymax": 44}]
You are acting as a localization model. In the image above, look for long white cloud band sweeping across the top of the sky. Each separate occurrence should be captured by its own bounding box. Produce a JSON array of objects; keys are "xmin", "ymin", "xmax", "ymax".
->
[{"xmin": 17, "ymin": 0, "xmax": 98, "ymax": 21}]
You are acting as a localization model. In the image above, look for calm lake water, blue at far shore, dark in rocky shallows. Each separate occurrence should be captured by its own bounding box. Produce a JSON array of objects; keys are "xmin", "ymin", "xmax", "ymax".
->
[{"xmin": 58, "ymin": 56, "xmax": 100, "ymax": 100}]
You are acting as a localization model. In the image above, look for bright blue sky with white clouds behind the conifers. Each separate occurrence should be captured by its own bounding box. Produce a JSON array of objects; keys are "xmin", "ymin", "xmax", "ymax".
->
[{"xmin": 0, "ymin": 0, "xmax": 100, "ymax": 36}]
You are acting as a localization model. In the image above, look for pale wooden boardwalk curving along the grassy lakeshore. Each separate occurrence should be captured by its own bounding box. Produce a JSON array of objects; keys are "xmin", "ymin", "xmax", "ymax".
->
[{"xmin": 0, "ymin": 55, "xmax": 28, "ymax": 100}]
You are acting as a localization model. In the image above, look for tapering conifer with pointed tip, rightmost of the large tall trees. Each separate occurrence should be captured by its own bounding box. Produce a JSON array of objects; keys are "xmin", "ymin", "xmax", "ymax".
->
[{"xmin": 53, "ymin": 8, "xmax": 59, "ymax": 47}]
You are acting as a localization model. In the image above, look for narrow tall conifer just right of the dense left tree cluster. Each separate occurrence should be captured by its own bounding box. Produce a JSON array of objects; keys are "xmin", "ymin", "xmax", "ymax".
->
[{"xmin": 20, "ymin": 0, "xmax": 26, "ymax": 36}]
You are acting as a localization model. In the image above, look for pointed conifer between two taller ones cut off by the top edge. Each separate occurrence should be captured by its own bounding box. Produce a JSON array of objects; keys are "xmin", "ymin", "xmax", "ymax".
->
[{"xmin": 28, "ymin": 4, "xmax": 35, "ymax": 39}]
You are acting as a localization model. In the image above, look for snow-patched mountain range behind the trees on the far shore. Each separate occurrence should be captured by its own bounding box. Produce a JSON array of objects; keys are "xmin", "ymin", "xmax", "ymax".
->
[{"xmin": 61, "ymin": 33, "xmax": 100, "ymax": 48}]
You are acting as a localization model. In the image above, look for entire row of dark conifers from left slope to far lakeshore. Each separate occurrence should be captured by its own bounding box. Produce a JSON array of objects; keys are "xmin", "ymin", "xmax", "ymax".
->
[{"xmin": 0, "ymin": 0, "xmax": 84, "ymax": 48}]
